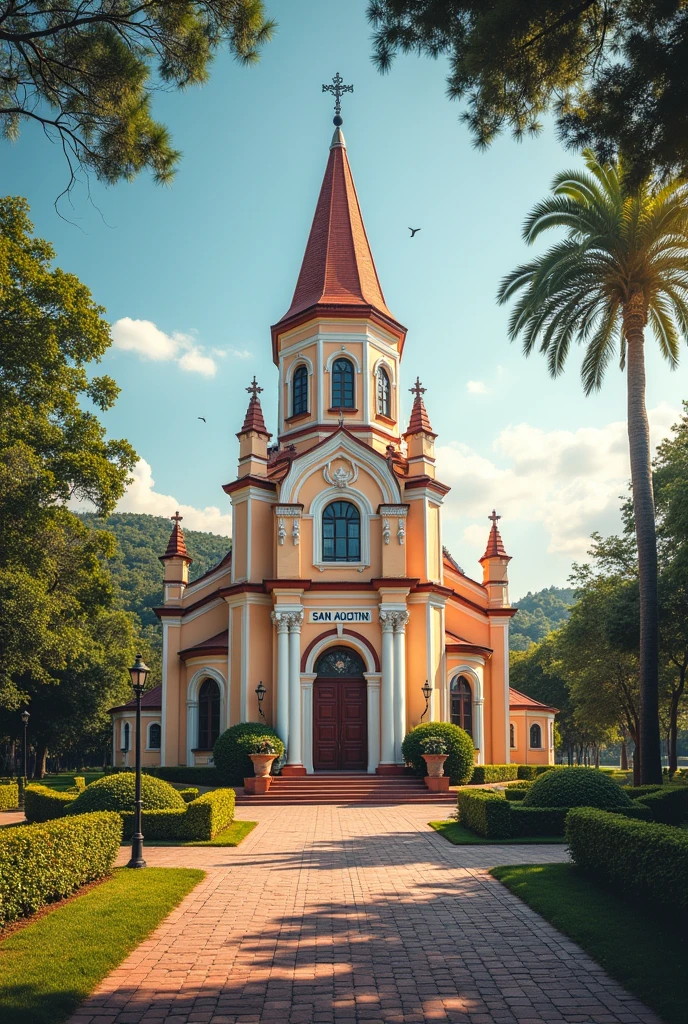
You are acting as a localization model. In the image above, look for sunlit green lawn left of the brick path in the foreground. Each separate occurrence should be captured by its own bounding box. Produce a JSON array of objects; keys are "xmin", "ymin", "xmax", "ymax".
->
[{"xmin": 0, "ymin": 867, "xmax": 205, "ymax": 1024}]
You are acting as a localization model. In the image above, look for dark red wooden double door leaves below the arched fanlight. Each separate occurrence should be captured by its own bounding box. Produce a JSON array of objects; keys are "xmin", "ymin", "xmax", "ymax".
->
[{"xmin": 313, "ymin": 676, "xmax": 368, "ymax": 771}]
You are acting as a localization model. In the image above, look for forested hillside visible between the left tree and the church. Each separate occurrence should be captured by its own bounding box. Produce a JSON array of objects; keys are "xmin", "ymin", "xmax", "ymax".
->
[{"xmin": 76, "ymin": 512, "xmax": 231, "ymax": 627}]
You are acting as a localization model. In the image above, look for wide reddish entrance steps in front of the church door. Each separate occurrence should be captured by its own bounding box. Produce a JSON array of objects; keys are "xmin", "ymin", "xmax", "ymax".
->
[{"xmin": 237, "ymin": 772, "xmax": 457, "ymax": 807}]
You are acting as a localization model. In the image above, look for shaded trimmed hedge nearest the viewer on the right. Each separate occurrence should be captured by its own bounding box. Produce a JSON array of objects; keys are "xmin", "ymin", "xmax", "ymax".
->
[{"xmin": 566, "ymin": 798, "xmax": 688, "ymax": 913}]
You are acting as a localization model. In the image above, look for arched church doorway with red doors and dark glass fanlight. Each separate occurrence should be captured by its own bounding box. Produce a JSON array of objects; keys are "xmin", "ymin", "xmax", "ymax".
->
[{"xmin": 313, "ymin": 647, "xmax": 368, "ymax": 771}]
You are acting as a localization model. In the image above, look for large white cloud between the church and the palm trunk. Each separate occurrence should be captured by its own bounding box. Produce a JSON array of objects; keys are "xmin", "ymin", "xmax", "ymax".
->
[{"xmin": 436, "ymin": 402, "xmax": 680, "ymax": 562}]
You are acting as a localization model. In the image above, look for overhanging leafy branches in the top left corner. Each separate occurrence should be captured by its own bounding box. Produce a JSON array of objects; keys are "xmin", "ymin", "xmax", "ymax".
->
[{"xmin": 0, "ymin": 0, "xmax": 274, "ymax": 188}]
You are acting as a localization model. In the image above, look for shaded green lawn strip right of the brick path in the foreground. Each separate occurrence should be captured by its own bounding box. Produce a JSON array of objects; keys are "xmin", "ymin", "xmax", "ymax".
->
[{"xmin": 490, "ymin": 864, "xmax": 688, "ymax": 1024}]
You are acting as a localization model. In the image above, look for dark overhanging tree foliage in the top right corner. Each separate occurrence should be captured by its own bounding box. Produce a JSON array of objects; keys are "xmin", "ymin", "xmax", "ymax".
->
[{"xmin": 368, "ymin": 0, "xmax": 688, "ymax": 180}]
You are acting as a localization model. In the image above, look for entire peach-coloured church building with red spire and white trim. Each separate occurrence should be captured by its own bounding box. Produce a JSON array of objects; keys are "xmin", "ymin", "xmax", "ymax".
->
[{"xmin": 112, "ymin": 119, "xmax": 555, "ymax": 775}]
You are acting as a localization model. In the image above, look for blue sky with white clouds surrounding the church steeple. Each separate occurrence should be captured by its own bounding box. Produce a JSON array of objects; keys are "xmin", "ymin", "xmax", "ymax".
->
[{"xmin": 6, "ymin": 0, "xmax": 688, "ymax": 597}]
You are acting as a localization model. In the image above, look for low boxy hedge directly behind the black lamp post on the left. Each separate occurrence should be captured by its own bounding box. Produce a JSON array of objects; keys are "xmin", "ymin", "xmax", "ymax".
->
[{"xmin": 121, "ymin": 790, "xmax": 235, "ymax": 841}]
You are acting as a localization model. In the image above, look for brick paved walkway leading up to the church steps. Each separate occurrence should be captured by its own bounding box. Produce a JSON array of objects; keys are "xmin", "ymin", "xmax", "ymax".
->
[{"xmin": 72, "ymin": 805, "xmax": 659, "ymax": 1024}]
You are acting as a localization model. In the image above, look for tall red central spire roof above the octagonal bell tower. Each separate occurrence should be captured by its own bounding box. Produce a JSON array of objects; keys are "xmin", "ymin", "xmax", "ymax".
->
[{"xmin": 272, "ymin": 127, "xmax": 405, "ymax": 356}]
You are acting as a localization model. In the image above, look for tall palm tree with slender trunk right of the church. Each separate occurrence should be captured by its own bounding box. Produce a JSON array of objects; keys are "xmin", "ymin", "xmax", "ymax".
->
[{"xmin": 499, "ymin": 150, "xmax": 688, "ymax": 782}]
